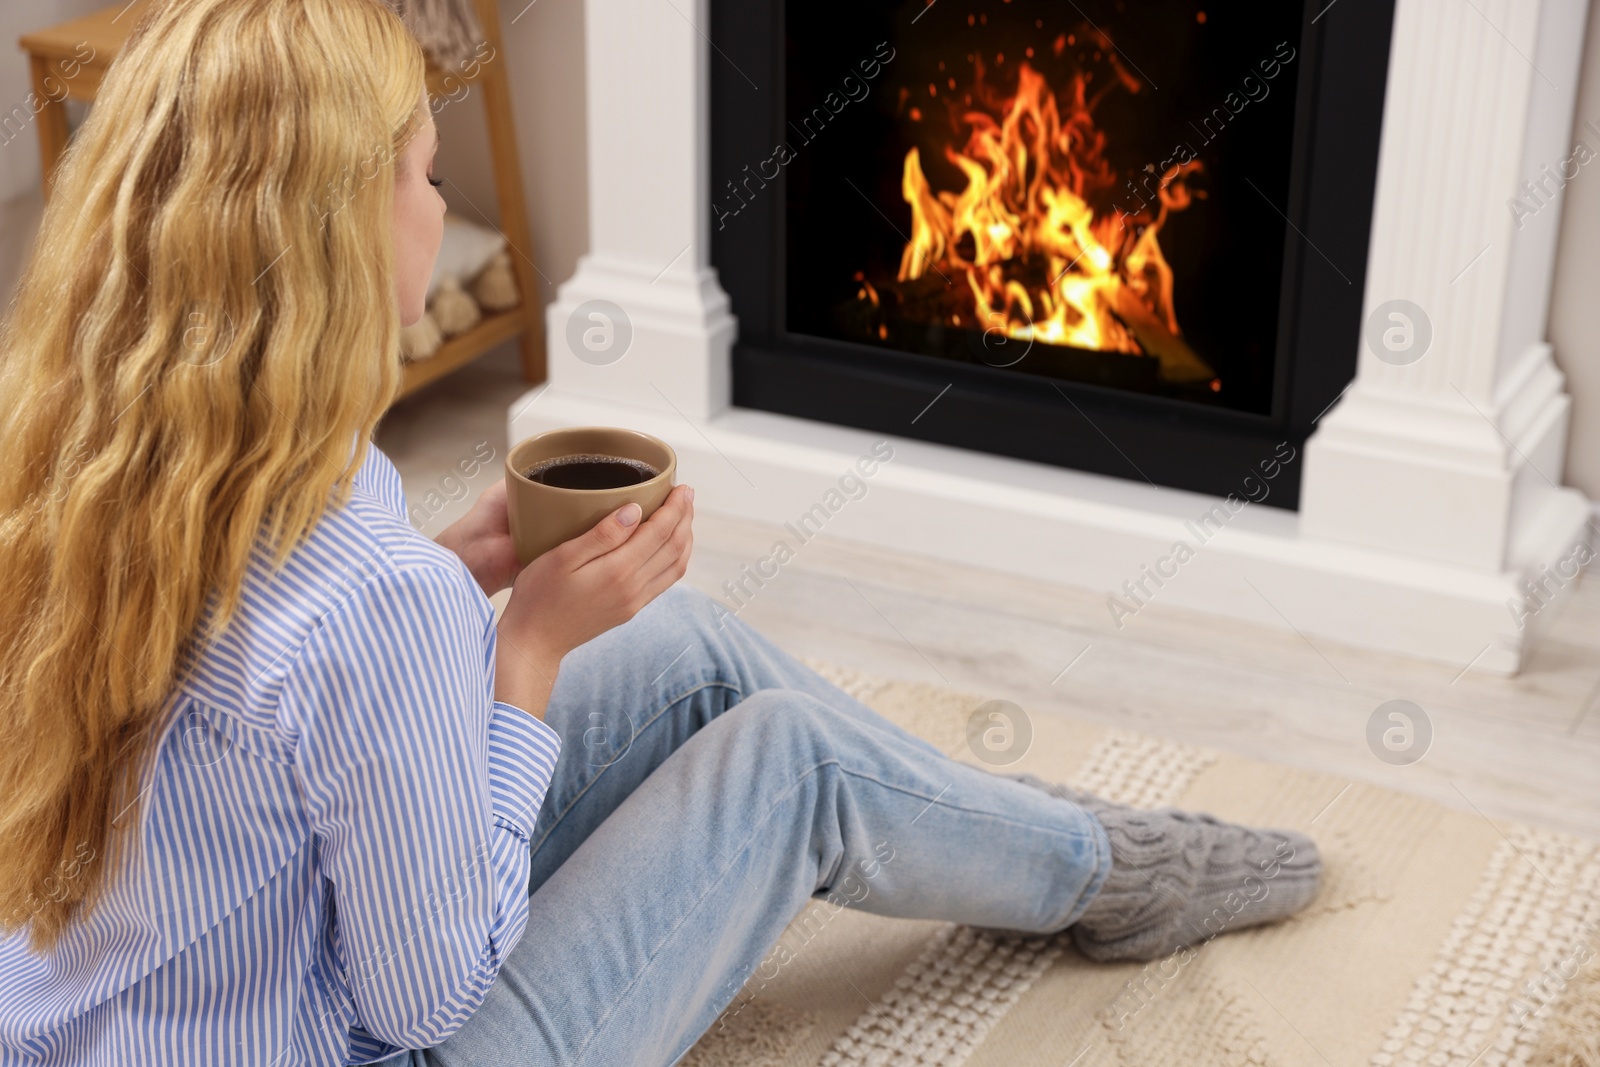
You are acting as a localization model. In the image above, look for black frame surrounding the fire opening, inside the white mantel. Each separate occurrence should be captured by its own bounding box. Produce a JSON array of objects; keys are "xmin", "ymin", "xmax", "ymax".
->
[{"xmin": 710, "ymin": 0, "xmax": 1395, "ymax": 509}]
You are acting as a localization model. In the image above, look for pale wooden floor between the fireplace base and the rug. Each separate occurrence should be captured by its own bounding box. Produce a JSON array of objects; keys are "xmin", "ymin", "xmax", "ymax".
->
[{"xmin": 378, "ymin": 349, "xmax": 1600, "ymax": 838}]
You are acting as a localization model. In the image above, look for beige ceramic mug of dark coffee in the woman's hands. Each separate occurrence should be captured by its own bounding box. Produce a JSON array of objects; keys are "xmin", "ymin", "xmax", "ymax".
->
[{"xmin": 506, "ymin": 426, "xmax": 678, "ymax": 566}]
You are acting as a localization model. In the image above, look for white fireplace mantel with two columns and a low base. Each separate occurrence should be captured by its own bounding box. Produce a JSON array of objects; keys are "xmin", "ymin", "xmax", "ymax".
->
[{"xmin": 509, "ymin": 0, "xmax": 1590, "ymax": 672}]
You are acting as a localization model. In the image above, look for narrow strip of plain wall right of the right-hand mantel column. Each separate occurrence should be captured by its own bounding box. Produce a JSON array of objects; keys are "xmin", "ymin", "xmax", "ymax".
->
[{"xmin": 1549, "ymin": 0, "xmax": 1600, "ymax": 499}]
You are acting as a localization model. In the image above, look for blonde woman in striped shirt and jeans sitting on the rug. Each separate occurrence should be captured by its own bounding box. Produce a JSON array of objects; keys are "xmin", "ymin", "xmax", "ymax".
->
[{"xmin": 0, "ymin": 0, "xmax": 1318, "ymax": 1067}]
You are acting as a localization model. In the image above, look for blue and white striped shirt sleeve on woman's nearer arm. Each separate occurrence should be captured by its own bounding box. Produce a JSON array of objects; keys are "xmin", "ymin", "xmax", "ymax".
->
[{"xmin": 285, "ymin": 566, "xmax": 560, "ymax": 1048}]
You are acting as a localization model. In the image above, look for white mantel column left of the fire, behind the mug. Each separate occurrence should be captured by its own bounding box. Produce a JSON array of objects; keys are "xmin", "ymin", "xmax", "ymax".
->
[{"xmin": 546, "ymin": 0, "xmax": 736, "ymax": 419}]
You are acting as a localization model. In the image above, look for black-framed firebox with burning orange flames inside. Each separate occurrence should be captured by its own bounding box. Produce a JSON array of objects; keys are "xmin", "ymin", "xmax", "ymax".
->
[{"xmin": 712, "ymin": 0, "xmax": 1394, "ymax": 507}]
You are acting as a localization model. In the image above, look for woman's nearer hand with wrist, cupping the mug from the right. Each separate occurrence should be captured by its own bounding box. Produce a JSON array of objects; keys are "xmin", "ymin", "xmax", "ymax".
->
[{"xmin": 494, "ymin": 485, "xmax": 694, "ymax": 718}]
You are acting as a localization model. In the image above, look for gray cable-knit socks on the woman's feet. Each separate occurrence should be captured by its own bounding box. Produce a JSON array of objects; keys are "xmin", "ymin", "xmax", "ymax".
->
[{"xmin": 1006, "ymin": 774, "xmax": 1322, "ymax": 960}]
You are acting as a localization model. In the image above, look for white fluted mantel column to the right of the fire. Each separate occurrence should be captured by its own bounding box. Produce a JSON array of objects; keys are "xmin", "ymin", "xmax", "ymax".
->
[{"xmin": 1301, "ymin": 0, "xmax": 1600, "ymax": 573}]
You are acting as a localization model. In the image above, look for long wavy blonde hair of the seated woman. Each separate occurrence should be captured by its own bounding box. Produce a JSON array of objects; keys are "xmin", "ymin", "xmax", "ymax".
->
[{"xmin": 0, "ymin": 0, "xmax": 427, "ymax": 952}]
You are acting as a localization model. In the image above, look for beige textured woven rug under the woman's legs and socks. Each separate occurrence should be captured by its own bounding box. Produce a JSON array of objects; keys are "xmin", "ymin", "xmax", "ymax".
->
[{"xmin": 682, "ymin": 662, "xmax": 1600, "ymax": 1067}]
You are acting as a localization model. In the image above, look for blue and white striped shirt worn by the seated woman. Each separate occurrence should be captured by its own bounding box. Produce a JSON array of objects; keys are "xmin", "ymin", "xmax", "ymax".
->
[{"xmin": 0, "ymin": 445, "xmax": 560, "ymax": 1067}]
